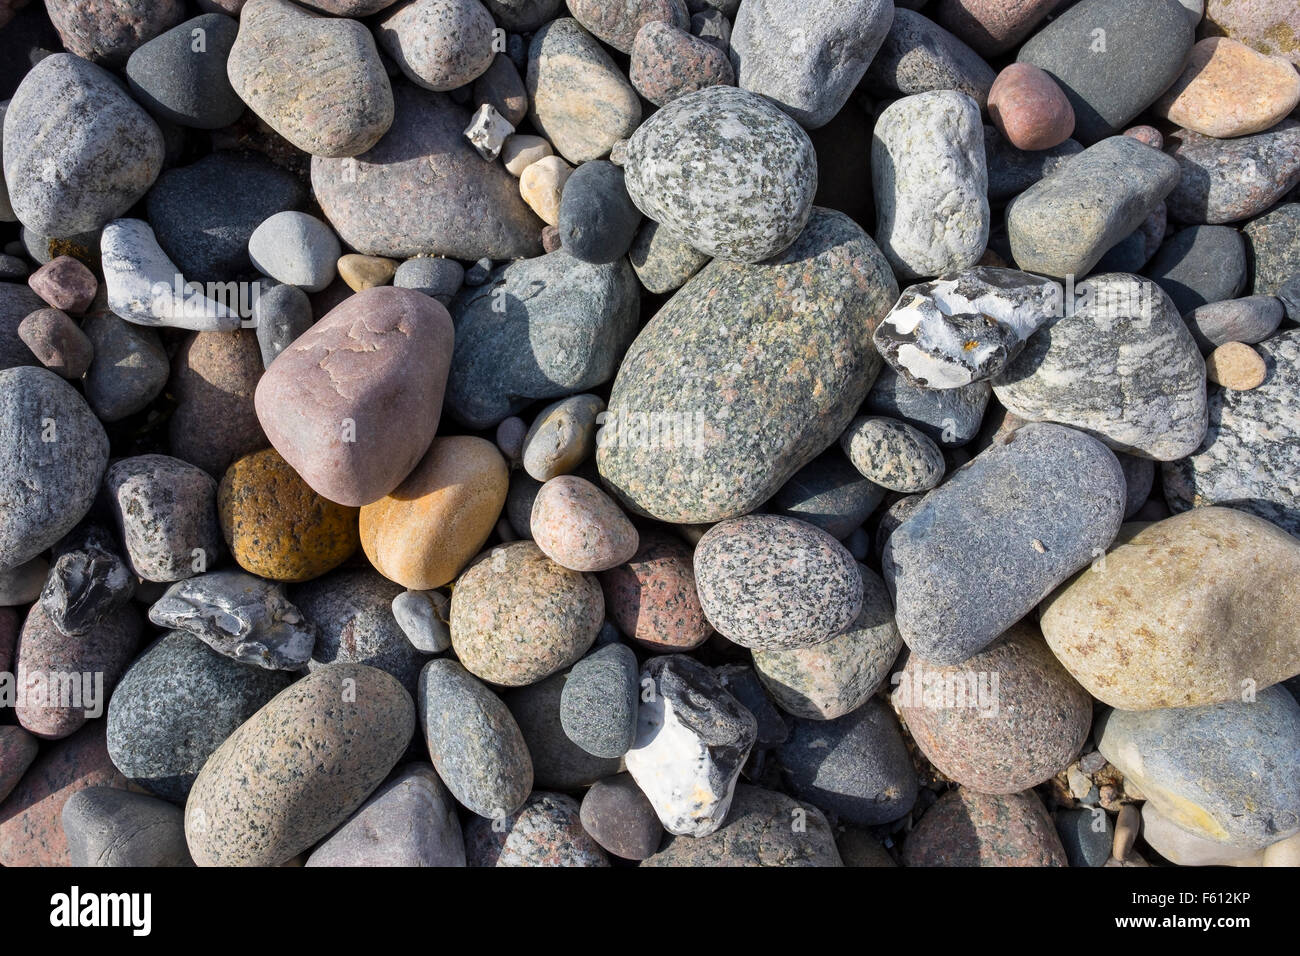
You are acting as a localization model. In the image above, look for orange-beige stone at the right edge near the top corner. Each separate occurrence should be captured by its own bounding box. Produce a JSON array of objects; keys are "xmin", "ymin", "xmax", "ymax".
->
[{"xmin": 1154, "ymin": 36, "xmax": 1300, "ymax": 139}]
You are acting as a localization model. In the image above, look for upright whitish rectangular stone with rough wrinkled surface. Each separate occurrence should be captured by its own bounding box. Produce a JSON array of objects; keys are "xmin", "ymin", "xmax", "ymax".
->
[{"xmin": 871, "ymin": 90, "xmax": 989, "ymax": 280}]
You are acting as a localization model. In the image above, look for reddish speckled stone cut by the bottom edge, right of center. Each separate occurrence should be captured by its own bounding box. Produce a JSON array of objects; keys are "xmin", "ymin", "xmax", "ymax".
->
[{"xmin": 902, "ymin": 787, "xmax": 1069, "ymax": 866}]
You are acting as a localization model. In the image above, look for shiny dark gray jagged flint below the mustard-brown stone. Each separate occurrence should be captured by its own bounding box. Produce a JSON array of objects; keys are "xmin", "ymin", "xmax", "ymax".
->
[{"xmin": 150, "ymin": 571, "xmax": 316, "ymax": 671}]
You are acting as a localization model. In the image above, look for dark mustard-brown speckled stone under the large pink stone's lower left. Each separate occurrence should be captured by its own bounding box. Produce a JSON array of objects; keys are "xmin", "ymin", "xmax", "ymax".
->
[{"xmin": 217, "ymin": 449, "xmax": 358, "ymax": 581}]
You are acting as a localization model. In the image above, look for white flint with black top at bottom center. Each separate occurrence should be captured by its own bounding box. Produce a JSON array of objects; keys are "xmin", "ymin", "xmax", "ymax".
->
[{"xmin": 627, "ymin": 654, "xmax": 758, "ymax": 836}]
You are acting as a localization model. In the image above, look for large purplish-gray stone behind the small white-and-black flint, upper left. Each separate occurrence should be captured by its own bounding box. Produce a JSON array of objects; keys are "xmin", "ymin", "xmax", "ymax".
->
[{"xmin": 312, "ymin": 86, "xmax": 542, "ymax": 261}]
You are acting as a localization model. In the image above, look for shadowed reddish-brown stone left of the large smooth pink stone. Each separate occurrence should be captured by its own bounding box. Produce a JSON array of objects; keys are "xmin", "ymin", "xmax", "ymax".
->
[{"xmin": 169, "ymin": 329, "xmax": 269, "ymax": 479}]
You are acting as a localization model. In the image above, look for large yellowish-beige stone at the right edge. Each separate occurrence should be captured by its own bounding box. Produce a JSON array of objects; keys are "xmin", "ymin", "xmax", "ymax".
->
[{"xmin": 1041, "ymin": 507, "xmax": 1300, "ymax": 710}]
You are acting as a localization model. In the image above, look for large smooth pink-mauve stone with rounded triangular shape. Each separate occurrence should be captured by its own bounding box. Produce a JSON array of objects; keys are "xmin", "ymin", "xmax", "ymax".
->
[{"xmin": 254, "ymin": 286, "xmax": 452, "ymax": 507}]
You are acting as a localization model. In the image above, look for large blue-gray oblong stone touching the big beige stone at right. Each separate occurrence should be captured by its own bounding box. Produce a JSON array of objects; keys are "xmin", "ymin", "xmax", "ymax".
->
[{"xmin": 881, "ymin": 423, "xmax": 1125, "ymax": 665}]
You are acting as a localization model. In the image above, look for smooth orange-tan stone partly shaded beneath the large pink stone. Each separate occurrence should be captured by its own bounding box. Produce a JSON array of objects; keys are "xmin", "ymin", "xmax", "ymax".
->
[{"xmin": 361, "ymin": 436, "xmax": 510, "ymax": 591}]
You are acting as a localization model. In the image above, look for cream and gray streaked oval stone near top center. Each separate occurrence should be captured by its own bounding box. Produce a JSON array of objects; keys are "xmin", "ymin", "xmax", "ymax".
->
[{"xmin": 527, "ymin": 17, "xmax": 641, "ymax": 163}]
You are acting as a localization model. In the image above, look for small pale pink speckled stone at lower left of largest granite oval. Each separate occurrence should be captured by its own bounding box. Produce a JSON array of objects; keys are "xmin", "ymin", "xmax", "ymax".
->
[{"xmin": 532, "ymin": 475, "xmax": 641, "ymax": 571}]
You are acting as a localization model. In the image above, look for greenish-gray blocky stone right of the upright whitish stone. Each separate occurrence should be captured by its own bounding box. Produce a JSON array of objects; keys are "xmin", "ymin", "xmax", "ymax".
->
[{"xmin": 1006, "ymin": 137, "xmax": 1179, "ymax": 278}]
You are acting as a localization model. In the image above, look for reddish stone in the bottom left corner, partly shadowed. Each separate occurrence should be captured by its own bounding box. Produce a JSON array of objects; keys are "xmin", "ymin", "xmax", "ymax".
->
[{"xmin": 0, "ymin": 721, "xmax": 126, "ymax": 866}]
